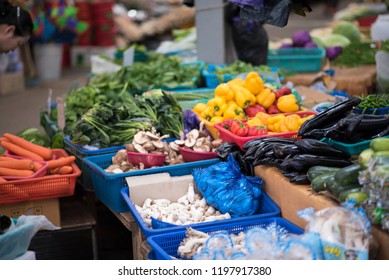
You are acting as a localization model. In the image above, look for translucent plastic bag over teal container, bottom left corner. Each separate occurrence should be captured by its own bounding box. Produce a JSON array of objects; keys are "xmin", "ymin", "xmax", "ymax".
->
[{"xmin": 0, "ymin": 215, "xmax": 59, "ymax": 260}]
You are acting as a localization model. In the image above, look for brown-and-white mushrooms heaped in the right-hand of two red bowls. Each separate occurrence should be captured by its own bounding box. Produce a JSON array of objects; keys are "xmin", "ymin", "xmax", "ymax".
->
[{"xmin": 170, "ymin": 127, "xmax": 222, "ymax": 152}]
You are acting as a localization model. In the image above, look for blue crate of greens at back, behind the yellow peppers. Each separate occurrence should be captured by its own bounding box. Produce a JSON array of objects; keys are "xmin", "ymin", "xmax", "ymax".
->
[{"xmin": 202, "ymin": 64, "xmax": 281, "ymax": 88}]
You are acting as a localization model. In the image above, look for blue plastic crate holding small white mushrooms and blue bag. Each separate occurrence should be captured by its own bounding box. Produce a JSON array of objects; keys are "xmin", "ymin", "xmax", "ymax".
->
[{"xmin": 121, "ymin": 183, "xmax": 281, "ymax": 238}]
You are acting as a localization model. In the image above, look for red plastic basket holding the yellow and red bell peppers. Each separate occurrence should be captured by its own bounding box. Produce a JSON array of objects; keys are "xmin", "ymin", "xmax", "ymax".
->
[{"xmin": 214, "ymin": 111, "xmax": 316, "ymax": 149}]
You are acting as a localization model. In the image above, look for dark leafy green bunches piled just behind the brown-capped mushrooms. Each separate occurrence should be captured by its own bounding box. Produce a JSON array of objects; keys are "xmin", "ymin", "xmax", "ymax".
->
[{"xmin": 69, "ymin": 92, "xmax": 183, "ymax": 148}]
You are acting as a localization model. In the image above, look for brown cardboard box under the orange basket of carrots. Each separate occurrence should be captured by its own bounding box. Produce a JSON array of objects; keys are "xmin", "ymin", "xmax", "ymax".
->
[{"xmin": 0, "ymin": 198, "xmax": 61, "ymax": 227}]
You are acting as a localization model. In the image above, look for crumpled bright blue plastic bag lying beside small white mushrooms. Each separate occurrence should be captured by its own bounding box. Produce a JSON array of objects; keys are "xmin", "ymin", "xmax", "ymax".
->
[{"xmin": 193, "ymin": 154, "xmax": 262, "ymax": 217}]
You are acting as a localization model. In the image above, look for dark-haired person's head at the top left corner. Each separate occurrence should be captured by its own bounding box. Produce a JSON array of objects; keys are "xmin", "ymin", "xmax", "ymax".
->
[{"xmin": 0, "ymin": 0, "xmax": 33, "ymax": 53}]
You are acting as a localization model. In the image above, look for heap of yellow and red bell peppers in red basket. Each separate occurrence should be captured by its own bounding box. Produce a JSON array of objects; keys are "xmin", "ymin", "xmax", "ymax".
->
[{"xmin": 193, "ymin": 72, "xmax": 300, "ymax": 124}]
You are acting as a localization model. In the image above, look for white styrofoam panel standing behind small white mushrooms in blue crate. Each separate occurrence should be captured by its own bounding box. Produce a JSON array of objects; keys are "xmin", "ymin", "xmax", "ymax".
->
[{"xmin": 126, "ymin": 173, "xmax": 193, "ymax": 206}]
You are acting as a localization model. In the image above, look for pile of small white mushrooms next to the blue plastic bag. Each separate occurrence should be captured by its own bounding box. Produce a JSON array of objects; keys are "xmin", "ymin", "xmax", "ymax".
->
[{"xmin": 135, "ymin": 183, "xmax": 231, "ymax": 227}]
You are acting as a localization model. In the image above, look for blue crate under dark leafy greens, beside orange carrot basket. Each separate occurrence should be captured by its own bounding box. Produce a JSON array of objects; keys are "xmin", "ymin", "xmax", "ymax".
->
[{"xmin": 65, "ymin": 137, "xmax": 124, "ymax": 191}]
